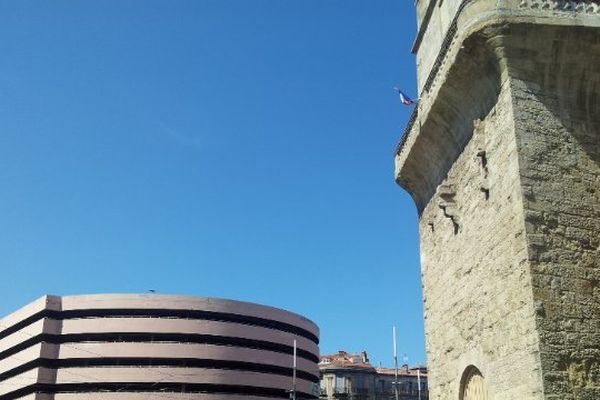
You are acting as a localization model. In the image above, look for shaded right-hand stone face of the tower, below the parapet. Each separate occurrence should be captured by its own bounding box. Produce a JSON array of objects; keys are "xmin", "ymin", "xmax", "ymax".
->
[{"xmin": 507, "ymin": 25, "xmax": 600, "ymax": 400}]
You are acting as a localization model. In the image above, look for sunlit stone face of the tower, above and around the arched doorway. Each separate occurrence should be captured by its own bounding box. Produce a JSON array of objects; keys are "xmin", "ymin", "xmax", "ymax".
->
[{"xmin": 420, "ymin": 72, "xmax": 542, "ymax": 400}]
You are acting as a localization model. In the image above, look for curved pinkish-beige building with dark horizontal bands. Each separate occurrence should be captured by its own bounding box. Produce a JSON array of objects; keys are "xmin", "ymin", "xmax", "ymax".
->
[{"xmin": 0, "ymin": 294, "xmax": 319, "ymax": 400}]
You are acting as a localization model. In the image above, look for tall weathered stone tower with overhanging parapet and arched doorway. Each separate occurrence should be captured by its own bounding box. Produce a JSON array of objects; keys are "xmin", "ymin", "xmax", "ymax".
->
[{"xmin": 395, "ymin": 0, "xmax": 600, "ymax": 400}]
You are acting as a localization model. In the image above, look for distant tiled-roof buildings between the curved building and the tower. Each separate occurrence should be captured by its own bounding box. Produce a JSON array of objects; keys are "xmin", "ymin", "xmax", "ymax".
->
[{"xmin": 319, "ymin": 351, "xmax": 429, "ymax": 400}]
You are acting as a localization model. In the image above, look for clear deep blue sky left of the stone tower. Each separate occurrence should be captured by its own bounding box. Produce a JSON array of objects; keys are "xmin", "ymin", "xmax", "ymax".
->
[{"xmin": 0, "ymin": 0, "xmax": 425, "ymax": 365}]
